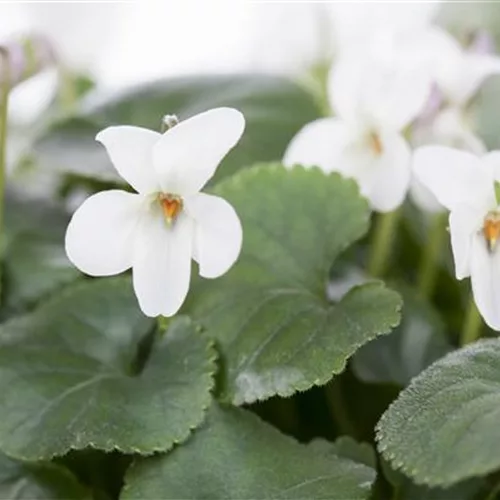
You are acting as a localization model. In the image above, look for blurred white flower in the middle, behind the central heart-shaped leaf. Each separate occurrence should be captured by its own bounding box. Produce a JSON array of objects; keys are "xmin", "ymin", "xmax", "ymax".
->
[{"xmin": 283, "ymin": 55, "xmax": 431, "ymax": 212}]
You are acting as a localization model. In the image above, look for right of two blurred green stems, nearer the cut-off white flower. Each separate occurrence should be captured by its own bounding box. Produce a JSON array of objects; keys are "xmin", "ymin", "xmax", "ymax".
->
[{"xmin": 418, "ymin": 213, "xmax": 447, "ymax": 297}]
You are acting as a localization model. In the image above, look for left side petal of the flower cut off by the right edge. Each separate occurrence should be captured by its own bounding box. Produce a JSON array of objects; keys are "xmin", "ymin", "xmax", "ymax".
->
[{"xmin": 449, "ymin": 205, "xmax": 484, "ymax": 280}]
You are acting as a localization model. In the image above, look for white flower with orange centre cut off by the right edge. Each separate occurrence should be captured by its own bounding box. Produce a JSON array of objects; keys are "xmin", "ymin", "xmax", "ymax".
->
[{"xmin": 414, "ymin": 146, "xmax": 500, "ymax": 330}]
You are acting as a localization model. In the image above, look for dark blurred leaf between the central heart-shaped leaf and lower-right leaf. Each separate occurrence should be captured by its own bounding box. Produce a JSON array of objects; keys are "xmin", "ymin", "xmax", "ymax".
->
[{"xmin": 352, "ymin": 286, "xmax": 451, "ymax": 386}]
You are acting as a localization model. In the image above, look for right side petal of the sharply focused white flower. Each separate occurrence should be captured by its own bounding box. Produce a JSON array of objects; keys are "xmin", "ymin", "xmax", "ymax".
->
[{"xmin": 184, "ymin": 193, "xmax": 243, "ymax": 278}]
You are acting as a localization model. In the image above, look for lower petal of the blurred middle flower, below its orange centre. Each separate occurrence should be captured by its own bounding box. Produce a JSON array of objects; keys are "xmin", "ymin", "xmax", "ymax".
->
[{"xmin": 336, "ymin": 128, "xmax": 411, "ymax": 212}]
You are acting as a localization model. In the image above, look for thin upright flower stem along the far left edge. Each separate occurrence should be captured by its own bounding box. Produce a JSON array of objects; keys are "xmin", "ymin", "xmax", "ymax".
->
[{"xmin": 0, "ymin": 47, "xmax": 10, "ymax": 300}]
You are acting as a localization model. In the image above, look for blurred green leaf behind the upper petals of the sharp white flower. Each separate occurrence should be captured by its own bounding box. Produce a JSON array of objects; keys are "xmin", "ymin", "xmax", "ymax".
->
[{"xmin": 34, "ymin": 75, "xmax": 320, "ymax": 187}]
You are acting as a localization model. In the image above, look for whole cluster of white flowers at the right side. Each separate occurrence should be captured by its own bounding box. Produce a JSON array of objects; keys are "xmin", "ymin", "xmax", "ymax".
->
[{"xmin": 283, "ymin": 9, "xmax": 500, "ymax": 330}]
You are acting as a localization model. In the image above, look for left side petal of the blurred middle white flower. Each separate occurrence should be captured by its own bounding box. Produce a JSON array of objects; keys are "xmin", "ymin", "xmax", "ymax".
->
[{"xmin": 283, "ymin": 118, "xmax": 350, "ymax": 172}]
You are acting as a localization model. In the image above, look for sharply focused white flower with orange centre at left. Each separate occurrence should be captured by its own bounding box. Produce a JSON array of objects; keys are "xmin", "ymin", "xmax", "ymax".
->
[{"xmin": 66, "ymin": 108, "xmax": 245, "ymax": 317}]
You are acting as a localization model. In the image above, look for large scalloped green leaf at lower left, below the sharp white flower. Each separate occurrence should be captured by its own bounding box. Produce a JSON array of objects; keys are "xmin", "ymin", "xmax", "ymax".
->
[{"xmin": 0, "ymin": 278, "xmax": 215, "ymax": 460}]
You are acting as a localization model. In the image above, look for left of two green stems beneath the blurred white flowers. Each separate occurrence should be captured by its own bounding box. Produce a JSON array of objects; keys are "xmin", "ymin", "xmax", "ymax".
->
[{"xmin": 368, "ymin": 209, "xmax": 401, "ymax": 278}]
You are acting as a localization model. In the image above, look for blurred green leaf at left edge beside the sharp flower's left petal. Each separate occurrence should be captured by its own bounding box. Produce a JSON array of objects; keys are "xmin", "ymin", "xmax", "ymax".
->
[{"xmin": 3, "ymin": 189, "xmax": 80, "ymax": 309}]
